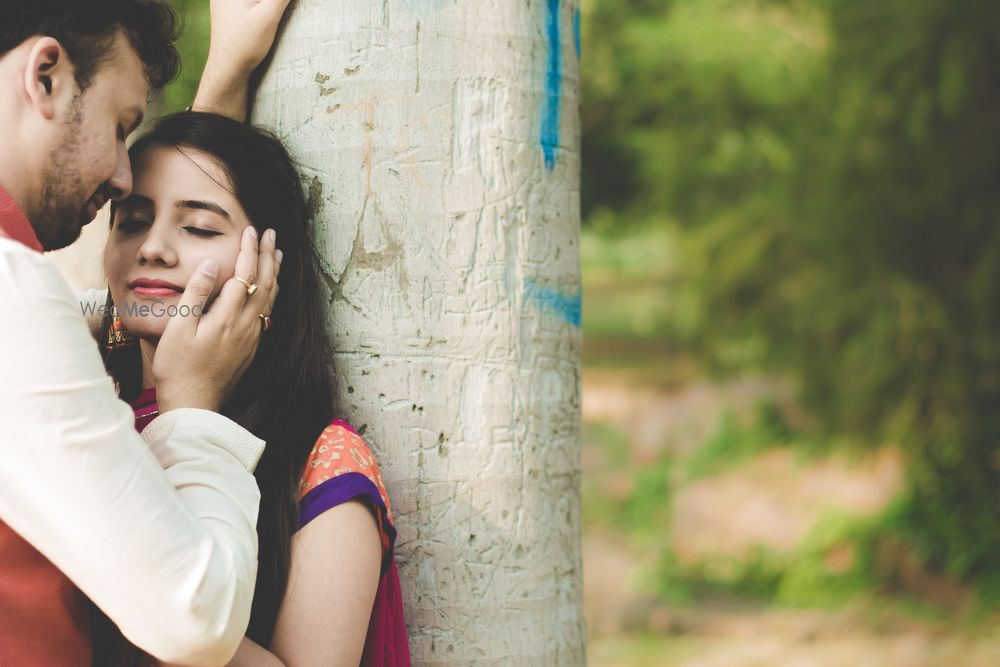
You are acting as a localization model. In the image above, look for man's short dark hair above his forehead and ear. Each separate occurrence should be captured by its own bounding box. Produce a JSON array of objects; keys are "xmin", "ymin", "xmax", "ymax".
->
[{"xmin": 0, "ymin": 0, "xmax": 180, "ymax": 91}]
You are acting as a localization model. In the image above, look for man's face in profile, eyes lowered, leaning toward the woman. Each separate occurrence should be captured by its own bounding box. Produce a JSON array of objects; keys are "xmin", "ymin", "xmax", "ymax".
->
[{"xmin": 34, "ymin": 33, "xmax": 149, "ymax": 250}]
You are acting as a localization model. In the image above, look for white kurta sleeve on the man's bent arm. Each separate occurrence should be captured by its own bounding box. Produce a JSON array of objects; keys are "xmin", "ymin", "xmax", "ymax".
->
[{"xmin": 0, "ymin": 236, "xmax": 264, "ymax": 665}]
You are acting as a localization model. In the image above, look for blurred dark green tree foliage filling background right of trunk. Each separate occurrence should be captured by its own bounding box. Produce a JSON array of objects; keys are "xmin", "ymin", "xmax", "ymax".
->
[{"xmin": 582, "ymin": 0, "xmax": 1000, "ymax": 601}]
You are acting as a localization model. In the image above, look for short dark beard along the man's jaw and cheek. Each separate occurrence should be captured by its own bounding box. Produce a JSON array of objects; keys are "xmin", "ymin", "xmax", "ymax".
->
[{"xmin": 34, "ymin": 94, "xmax": 90, "ymax": 250}]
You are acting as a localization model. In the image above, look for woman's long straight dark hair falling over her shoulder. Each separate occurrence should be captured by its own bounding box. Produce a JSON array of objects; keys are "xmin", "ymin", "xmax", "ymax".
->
[{"xmin": 103, "ymin": 112, "xmax": 333, "ymax": 647}]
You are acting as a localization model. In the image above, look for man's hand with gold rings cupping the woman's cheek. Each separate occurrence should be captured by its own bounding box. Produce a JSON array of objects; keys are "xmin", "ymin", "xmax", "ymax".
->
[{"xmin": 153, "ymin": 227, "xmax": 281, "ymax": 413}]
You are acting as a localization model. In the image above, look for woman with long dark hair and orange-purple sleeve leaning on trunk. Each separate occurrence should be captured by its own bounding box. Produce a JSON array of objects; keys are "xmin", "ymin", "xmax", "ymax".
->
[{"xmin": 96, "ymin": 113, "xmax": 409, "ymax": 665}]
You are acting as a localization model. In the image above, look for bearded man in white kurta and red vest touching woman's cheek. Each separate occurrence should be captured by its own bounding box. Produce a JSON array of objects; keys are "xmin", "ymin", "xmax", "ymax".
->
[{"xmin": 0, "ymin": 0, "xmax": 287, "ymax": 665}]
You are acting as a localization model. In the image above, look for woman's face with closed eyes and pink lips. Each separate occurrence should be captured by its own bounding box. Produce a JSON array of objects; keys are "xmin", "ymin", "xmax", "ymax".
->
[{"xmin": 104, "ymin": 146, "xmax": 250, "ymax": 340}]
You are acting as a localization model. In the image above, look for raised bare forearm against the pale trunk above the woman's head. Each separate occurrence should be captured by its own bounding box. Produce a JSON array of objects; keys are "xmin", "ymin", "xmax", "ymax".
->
[{"xmin": 192, "ymin": 0, "xmax": 289, "ymax": 122}]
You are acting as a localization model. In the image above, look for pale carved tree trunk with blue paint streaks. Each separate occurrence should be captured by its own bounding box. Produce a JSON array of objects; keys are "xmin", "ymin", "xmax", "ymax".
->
[{"xmin": 253, "ymin": 0, "xmax": 584, "ymax": 665}]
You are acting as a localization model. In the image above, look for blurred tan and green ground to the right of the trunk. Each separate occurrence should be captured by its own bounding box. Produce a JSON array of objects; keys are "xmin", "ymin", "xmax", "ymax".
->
[{"xmin": 582, "ymin": 227, "xmax": 1000, "ymax": 667}]
